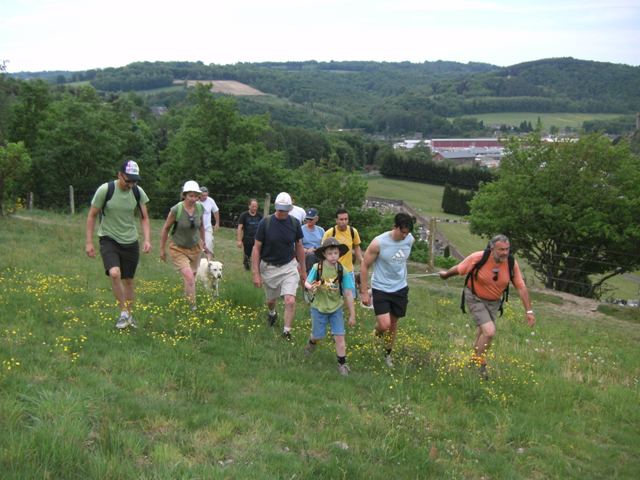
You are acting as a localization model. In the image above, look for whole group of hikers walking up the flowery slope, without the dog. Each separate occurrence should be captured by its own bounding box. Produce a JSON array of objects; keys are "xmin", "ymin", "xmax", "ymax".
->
[{"xmin": 85, "ymin": 160, "xmax": 535, "ymax": 379}]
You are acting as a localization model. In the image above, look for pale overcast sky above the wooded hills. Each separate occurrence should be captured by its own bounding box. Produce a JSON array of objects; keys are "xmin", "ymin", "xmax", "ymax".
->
[{"xmin": 0, "ymin": 0, "xmax": 640, "ymax": 73}]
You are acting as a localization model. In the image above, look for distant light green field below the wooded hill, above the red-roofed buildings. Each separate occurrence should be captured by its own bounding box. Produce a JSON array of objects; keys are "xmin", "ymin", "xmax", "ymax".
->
[{"xmin": 458, "ymin": 112, "xmax": 620, "ymax": 130}]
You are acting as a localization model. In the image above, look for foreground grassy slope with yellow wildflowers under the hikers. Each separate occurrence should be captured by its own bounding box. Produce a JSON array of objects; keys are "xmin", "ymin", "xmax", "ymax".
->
[{"xmin": 0, "ymin": 214, "xmax": 640, "ymax": 479}]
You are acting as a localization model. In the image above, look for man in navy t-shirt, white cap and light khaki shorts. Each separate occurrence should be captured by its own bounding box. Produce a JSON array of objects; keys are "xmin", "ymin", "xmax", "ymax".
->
[{"xmin": 251, "ymin": 192, "xmax": 307, "ymax": 340}]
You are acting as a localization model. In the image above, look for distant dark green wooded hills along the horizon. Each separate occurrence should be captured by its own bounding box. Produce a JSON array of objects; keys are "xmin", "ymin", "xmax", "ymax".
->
[{"xmin": 15, "ymin": 58, "xmax": 640, "ymax": 136}]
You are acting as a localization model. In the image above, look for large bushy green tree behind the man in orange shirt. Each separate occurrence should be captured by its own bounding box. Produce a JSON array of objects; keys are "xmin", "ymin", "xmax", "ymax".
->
[{"xmin": 471, "ymin": 135, "xmax": 640, "ymax": 297}]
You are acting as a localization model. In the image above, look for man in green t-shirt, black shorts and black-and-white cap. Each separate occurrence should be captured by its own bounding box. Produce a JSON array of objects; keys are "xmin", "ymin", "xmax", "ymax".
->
[{"xmin": 85, "ymin": 160, "xmax": 151, "ymax": 329}]
